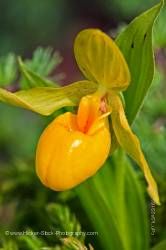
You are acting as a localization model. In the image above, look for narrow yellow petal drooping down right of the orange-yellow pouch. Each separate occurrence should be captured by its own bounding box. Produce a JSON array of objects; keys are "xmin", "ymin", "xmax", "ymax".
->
[{"xmin": 109, "ymin": 92, "xmax": 160, "ymax": 205}]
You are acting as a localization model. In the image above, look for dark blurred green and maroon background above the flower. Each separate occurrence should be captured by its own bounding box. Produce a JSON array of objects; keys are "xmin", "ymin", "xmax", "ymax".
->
[{"xmin": 0, "ymin": 0, "xmax": 163, "ymax": 83}]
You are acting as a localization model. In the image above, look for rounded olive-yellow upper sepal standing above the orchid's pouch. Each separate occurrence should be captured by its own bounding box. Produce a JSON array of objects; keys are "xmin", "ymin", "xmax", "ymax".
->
[{"xmin": 74, "ymin": 29, "xmax": 130, "ymax": 90}]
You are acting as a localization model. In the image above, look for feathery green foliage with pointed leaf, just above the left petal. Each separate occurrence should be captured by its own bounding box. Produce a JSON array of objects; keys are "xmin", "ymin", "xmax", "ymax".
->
[{"xmin": 0, "ymin": 47, "xmax": 64, "ymax": 89}]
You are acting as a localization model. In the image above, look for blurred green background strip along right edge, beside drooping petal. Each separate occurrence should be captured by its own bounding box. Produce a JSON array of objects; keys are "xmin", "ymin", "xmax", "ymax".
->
[{"xmin": 134, "ymin": 69, "xmax": 166, "ymax": 245}]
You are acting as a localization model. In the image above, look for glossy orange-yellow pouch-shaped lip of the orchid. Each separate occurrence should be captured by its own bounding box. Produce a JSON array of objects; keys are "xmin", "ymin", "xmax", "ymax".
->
[{"xmin": 36, "ymin": 96, "xmax": 111, "ymax": 191}]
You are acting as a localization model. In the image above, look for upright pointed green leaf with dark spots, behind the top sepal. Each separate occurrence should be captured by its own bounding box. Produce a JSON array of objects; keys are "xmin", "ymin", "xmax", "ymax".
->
[{"xmin": 116, "ymin": 1, "xmax": 163, "ymax": 123}]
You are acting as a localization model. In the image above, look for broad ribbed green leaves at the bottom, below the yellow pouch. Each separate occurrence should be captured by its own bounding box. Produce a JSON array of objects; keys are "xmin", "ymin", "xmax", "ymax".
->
[{"xmin": 76, "ymin": 151, "xmax": 148, "ymax": 250}]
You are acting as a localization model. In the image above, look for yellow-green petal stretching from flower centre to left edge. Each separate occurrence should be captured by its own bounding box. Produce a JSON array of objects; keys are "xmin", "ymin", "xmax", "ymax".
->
[{"xmin": 0, "ymin": 81, "xmax": 97, "ymax": 115}]
